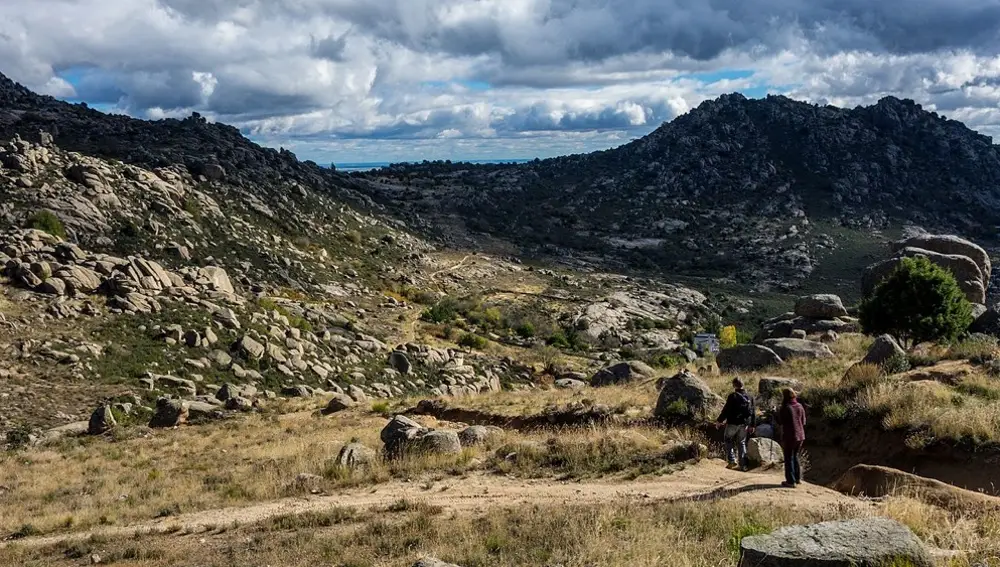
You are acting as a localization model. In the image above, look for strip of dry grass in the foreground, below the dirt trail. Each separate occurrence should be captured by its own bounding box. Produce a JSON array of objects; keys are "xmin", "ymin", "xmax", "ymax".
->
[{"xmin": 0, "ymin": 492, "xmax": 1000, "ymax": 567}]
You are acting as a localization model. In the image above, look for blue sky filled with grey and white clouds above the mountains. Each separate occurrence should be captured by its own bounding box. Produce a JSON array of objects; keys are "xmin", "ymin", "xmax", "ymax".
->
[{"xmin": 0, "ymin": 0, "xmax": 1000, "ymax": 163}]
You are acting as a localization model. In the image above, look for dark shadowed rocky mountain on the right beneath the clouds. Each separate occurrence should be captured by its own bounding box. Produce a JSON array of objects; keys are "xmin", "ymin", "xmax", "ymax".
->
[{"xmin": 355, "ymin": 94, "xmax": 1000, "ymax": 295}]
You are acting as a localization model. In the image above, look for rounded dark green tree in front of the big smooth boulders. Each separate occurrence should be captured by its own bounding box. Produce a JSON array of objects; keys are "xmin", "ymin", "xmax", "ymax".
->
[{"xmin": 859, "ymin": 258, "xmax": 972, "ymax": 346}]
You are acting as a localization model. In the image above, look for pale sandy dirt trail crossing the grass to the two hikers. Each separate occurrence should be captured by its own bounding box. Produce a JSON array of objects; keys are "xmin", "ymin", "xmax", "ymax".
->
[{"xmin": 0, "ymin": 461, "xmax": 866, "ymax": 547}]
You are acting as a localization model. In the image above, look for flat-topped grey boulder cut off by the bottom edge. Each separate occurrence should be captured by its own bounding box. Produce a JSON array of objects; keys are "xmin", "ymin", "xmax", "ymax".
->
[{"xmin": 740, "ymin": 518, "xmax": 934, "ymax": 567}]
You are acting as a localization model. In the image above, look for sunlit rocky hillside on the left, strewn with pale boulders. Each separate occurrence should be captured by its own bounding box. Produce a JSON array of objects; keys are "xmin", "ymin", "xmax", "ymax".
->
[{"xmin": 0, "ymin": 73, "xmax": 728, "ymax": 435}]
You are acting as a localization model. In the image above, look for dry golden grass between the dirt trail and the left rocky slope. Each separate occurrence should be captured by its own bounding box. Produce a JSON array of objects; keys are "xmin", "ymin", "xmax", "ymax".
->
[{"xmin": 0, "ymin": 402, "xmax": 704, "ymax": 535}]
